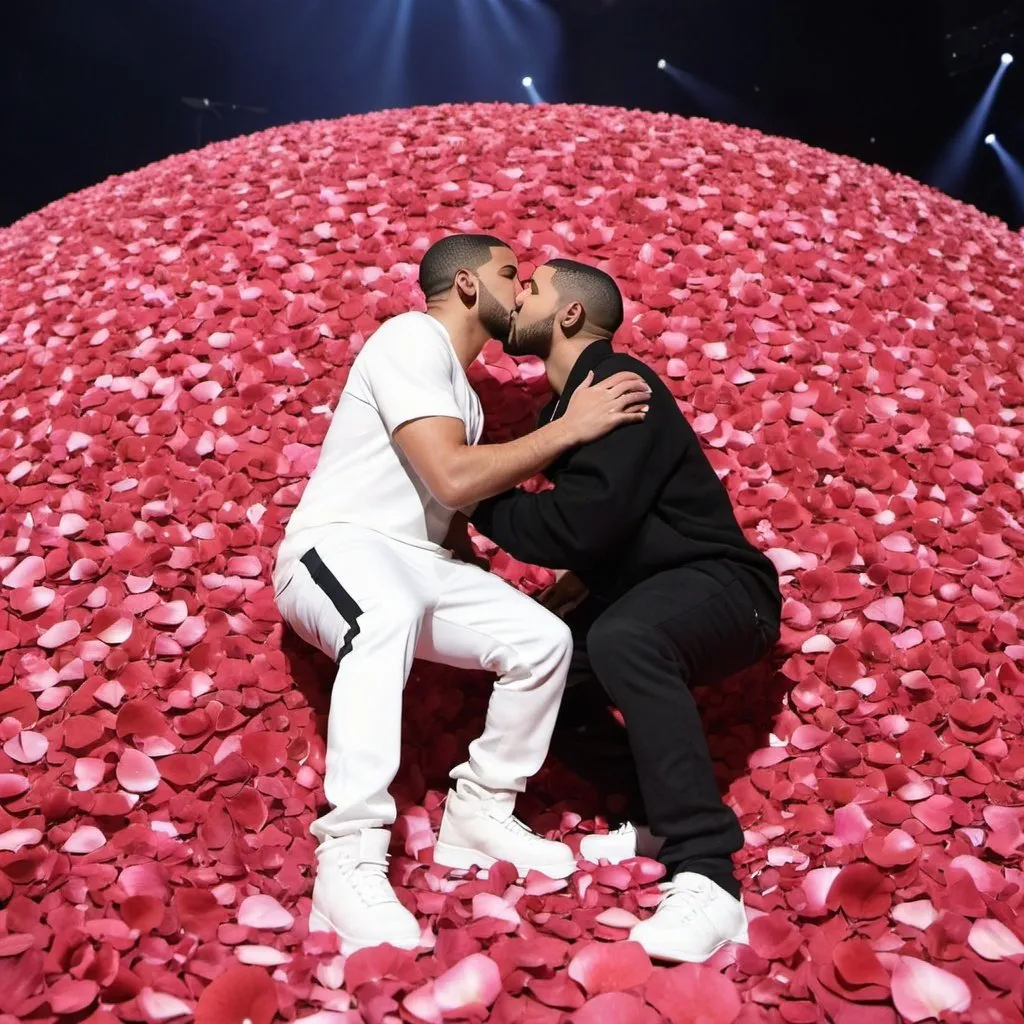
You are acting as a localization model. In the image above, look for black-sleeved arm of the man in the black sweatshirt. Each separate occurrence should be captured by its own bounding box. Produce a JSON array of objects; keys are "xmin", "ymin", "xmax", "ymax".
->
[{"xmin": 470, "ymin": 366, "xmax": 679, "ymax": 570}]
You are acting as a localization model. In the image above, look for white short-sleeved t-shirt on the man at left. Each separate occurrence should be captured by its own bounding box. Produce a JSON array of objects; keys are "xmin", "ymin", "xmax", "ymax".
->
[{"xmin": 275, "ymin": 312, "xmax": 483, "ymax": 575}]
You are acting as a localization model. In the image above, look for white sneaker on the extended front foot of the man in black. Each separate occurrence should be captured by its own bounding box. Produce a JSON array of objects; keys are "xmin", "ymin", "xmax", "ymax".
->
[{"xmin": 630, "ymin": 871, "xmax": 749, "ymax": 964}]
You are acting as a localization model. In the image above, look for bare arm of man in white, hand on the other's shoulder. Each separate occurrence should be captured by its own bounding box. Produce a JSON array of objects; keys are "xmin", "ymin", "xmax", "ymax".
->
[{"xmin": 393, "ymin": 373, "xmax": 648, "ymax": 509}]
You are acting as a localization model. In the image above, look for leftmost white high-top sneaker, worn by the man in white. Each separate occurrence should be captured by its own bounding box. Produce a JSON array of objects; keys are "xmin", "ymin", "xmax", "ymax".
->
[{"xmin": 309, "ymin": 828, "xmax": 420, "ymax": 953}]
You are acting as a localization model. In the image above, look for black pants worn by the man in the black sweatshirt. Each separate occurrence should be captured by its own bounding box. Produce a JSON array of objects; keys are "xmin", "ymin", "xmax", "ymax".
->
[{"xmin": 553, "ymin": 563, "xmax": 780, "ymax": 889}]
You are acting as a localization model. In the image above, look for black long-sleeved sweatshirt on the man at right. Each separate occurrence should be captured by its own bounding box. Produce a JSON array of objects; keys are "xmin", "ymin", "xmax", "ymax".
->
[{"xmin": 471, "ymin": 341, "xmax": 780, "ymax": 607}]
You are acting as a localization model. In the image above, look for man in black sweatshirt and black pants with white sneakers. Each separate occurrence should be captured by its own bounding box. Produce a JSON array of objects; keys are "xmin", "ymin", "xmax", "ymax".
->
[{"xmin": 471, "ymin": 260, "xmax": 781, "ymax": 962}]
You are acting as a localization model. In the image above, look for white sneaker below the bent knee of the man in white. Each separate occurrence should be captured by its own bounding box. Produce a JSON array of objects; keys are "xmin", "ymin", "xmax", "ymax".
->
[{"xmin": 434, "ymin": 790, "xmax": 575, "ymax": 879}]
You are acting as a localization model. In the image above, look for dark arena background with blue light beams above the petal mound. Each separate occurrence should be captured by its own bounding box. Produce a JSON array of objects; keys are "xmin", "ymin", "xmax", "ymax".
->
[{"xmin": 0, "ymin": 0, "xmax": 1024, "ymax": 227}]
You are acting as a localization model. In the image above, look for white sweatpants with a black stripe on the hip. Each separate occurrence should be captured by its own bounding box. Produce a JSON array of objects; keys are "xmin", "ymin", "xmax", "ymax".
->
[{"xmin": 276, "ymin": 526, "xmax": 572, "ymax": 842}]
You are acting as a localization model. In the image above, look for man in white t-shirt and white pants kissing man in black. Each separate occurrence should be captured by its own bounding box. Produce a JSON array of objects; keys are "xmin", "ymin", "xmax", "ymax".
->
[{"xmin": 273, "ymin": 234, "xmax": 649, "ymax": 949}]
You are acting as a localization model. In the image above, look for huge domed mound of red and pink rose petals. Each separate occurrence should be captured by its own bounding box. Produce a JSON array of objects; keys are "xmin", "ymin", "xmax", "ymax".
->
[{"xmin": 0, "ymin": 105, "xmax": 1024, "ymax": 1024}]
